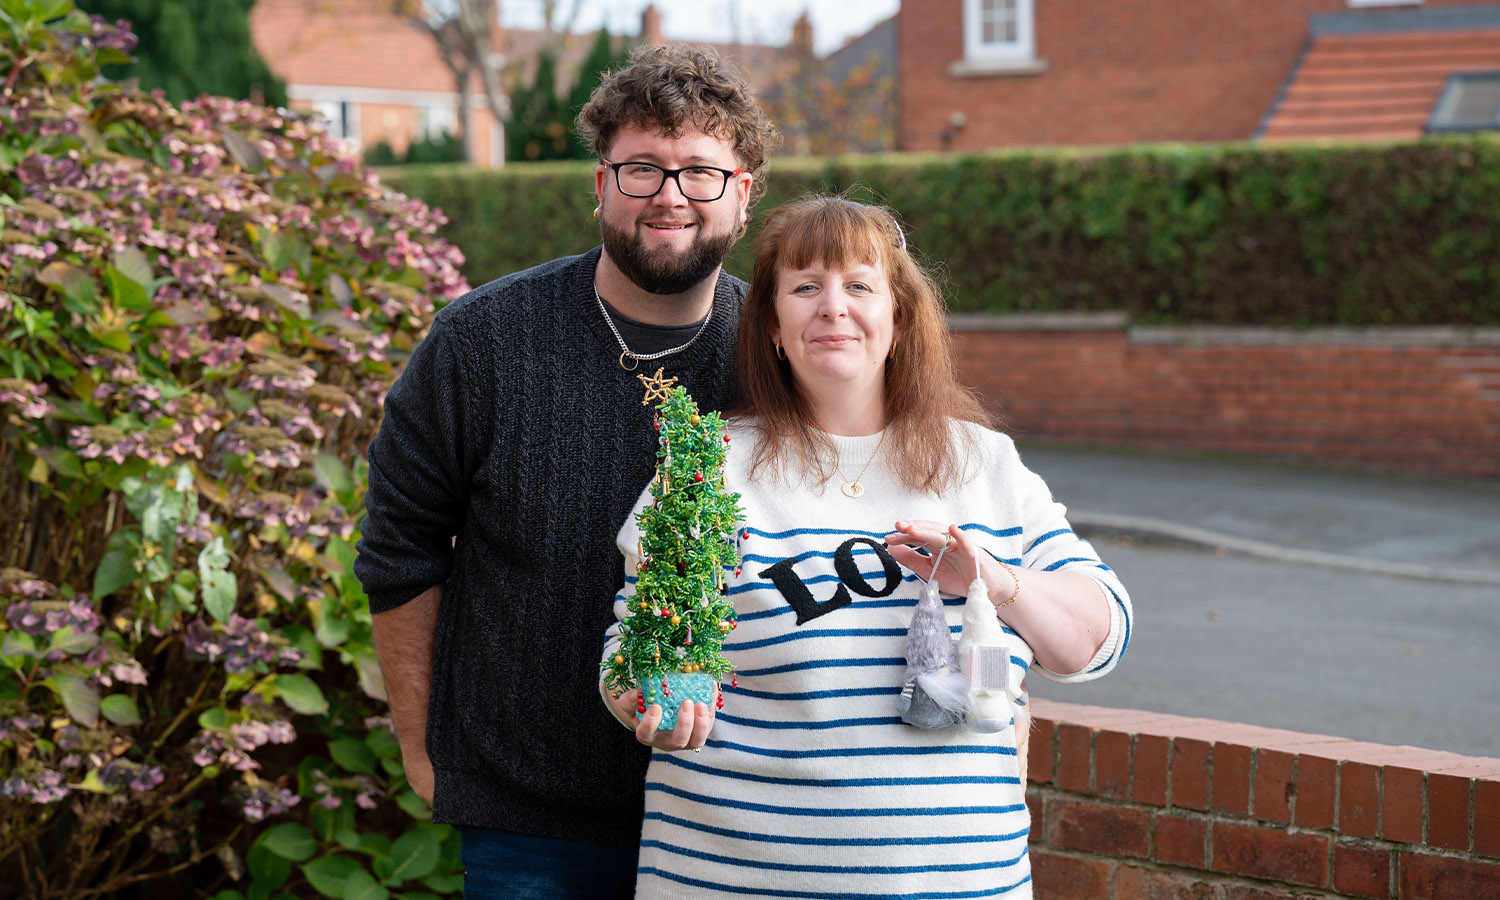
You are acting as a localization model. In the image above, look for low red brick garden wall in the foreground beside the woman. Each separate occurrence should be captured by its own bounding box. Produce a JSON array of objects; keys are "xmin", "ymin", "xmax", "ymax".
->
[{"xmin": 1028, "ymin": 701, "xmax": 1500, "ymax": 900}]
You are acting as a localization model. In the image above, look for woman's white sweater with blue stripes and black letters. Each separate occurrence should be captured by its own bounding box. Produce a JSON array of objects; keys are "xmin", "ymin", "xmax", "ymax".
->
[{"xmin": 605, "ymin": 423, "xmax": 1131, "ymax": 900}]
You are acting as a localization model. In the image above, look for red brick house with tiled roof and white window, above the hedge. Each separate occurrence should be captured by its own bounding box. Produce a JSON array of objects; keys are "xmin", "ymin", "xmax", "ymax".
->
[{"xmin": 899, "ymin": 0, "xmax": 1500, "ymax": 150}]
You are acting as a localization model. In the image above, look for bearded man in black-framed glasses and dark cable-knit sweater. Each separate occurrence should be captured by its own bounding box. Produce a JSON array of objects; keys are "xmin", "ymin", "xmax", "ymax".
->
[{"xmin": 354, "ymin": 47, "xmax": 779, "ymax": 900}]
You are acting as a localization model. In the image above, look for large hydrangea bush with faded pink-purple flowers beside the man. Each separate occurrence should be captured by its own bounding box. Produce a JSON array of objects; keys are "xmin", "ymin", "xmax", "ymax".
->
[{"xmin": 0, "ymin": 0, "xmax": 467, "ymax": 900}]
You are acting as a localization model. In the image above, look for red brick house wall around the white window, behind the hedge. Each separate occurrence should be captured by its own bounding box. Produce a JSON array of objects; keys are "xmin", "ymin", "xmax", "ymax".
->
[{"xmin": 899, "ymin": 0, "xmax": 1482, "ymax": 150}]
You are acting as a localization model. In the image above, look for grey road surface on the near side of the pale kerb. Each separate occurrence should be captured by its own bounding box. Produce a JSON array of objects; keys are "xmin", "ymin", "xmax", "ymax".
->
[{"xmin": 1029, "ymin": 537, "xmax": 1500, "ymax": 758}]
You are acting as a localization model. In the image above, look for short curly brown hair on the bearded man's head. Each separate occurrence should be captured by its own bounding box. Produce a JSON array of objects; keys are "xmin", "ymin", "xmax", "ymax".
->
[{"xmin": 578, "ymin": 44, "xmax": 782, "ymax": 204}]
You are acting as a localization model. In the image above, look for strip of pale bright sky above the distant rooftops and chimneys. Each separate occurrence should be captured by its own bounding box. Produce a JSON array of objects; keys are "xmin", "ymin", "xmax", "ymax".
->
[{"xmin": 500, "ymin": 0, "xmax": 900, "ymax": 53}]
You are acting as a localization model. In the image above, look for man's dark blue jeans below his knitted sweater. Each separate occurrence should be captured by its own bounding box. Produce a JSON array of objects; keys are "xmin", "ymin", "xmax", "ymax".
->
[{"xmin": 459, "ymin": 827, "xmax": 636, "ymax": 900}]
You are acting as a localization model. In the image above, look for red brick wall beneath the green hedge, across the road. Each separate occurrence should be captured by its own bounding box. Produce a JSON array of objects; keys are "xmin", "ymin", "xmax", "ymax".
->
[{"xmin": 954, "ymin": 317, "xmax": 1500, "ymax": 477}]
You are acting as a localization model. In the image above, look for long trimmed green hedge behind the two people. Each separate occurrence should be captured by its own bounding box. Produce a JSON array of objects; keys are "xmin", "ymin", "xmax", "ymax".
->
[{"xmin": 389, "ymin": 137, "xmax": 1500, "ymax": 326}]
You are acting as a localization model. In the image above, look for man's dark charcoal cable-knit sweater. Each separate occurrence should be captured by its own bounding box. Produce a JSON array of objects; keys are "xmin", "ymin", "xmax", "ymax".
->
[{"xmin": 354, "ymin": 248, "xmax": 744, "ymax": 846}]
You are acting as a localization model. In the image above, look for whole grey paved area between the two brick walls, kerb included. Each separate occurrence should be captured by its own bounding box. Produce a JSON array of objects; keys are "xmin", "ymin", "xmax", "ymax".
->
[{"xmin": 1019, "ymin": 440, "xmax": 1500, "ymax": 758}]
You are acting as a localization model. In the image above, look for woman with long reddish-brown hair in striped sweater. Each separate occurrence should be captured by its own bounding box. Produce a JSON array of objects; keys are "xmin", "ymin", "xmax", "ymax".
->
[{"xmin": 606, "ymin": 197, "xmax": 1131, "ymax": 897}]
